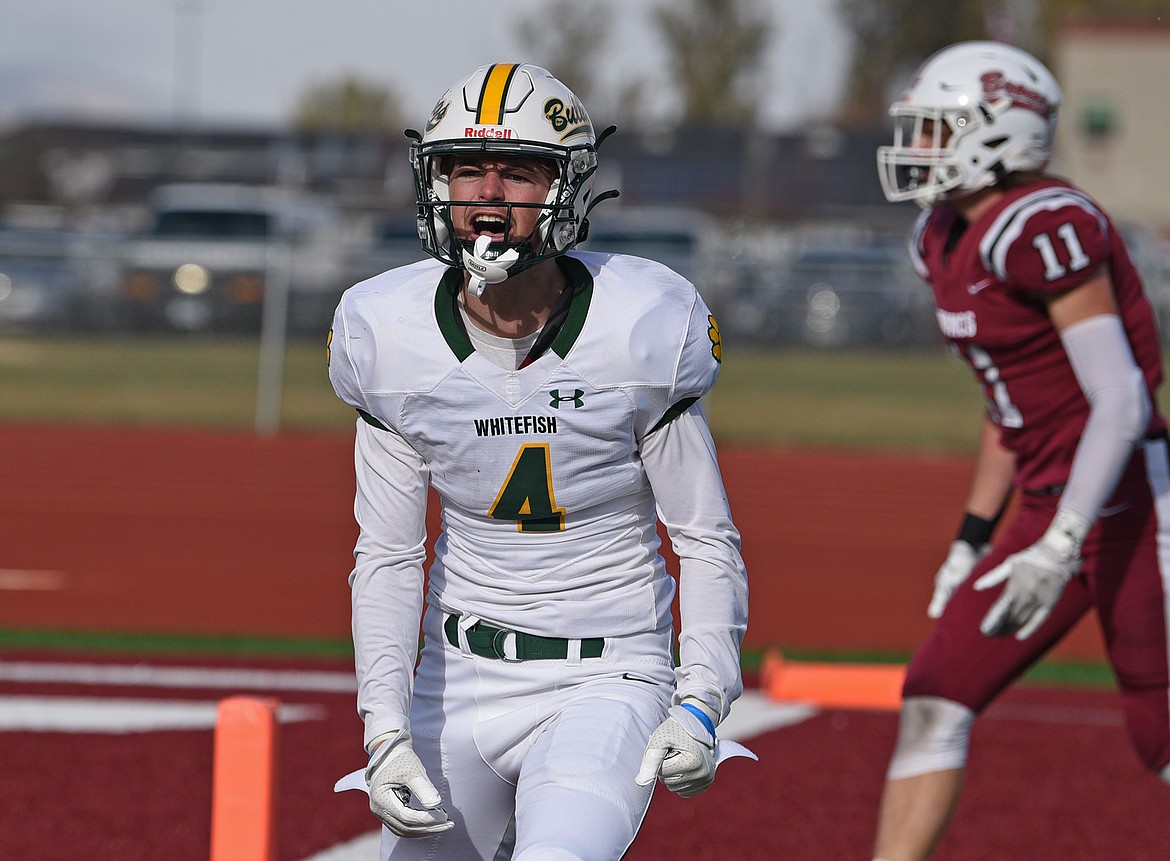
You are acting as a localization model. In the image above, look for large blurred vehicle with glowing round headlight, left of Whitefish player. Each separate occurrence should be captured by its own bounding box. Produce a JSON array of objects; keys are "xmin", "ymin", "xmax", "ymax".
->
[{"xmin": 89, "ymin": 184, "xmax": 345, "ymax": 332}]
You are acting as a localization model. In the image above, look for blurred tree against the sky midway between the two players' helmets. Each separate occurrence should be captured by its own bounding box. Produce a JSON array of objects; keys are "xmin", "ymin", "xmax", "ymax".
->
[{"xmin": 653, "ymin": 0, "xmax": 772, "ymax": 126}]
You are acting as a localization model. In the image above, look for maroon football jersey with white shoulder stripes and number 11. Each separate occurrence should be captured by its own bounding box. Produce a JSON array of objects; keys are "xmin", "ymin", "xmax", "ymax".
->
[{"xmin": 911, "ymin": 180, "xmax": 1165, "ymax": 490}]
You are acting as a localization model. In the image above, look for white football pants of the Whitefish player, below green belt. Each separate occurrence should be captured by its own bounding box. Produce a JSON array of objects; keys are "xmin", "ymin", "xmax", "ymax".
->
[{"xmin": 381, "ymin": 608, "xmax": 674, "ymax": 861}]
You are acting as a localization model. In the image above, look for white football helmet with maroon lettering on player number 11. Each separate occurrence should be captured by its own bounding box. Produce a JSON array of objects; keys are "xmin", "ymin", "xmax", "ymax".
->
[{"xmin": 878, "ymin": 42, "xmax": 1061, "ymax": 207}]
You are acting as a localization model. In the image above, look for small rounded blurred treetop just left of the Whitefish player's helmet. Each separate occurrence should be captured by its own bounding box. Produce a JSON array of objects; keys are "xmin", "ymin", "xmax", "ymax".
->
[{"xmin": 294, "ymin": 75, "xmax": 402, "ymax": 136}]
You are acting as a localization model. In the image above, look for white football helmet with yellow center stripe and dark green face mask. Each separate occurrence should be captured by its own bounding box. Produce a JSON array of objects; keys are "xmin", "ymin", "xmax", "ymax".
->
[{"xmin": 406, "ymin": 63, "xmax": 617, "ymax": 292}]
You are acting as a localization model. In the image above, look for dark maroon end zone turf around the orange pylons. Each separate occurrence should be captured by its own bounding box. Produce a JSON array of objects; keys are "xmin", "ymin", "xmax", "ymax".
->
[{"xmin": 0, "ymin": 654, "xmax": 1170, "ymax": 861}]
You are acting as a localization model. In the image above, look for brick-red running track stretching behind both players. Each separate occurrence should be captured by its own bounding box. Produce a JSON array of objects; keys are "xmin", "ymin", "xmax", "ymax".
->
[{"xmin": 0, "ymin": 427, "xmax": 1101, "ymax": 660}]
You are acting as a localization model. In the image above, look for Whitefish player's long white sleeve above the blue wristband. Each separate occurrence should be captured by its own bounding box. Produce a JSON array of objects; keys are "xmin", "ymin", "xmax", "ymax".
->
[{"xmin": 641, "ymin": 404, "xmax": 748, "ymax": 719}]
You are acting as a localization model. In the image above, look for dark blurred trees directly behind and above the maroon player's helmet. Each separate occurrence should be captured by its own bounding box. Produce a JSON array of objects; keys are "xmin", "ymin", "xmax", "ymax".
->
[{"xmin": 838, "ymin": 0, "xmax": 1168, "ymax": 125}]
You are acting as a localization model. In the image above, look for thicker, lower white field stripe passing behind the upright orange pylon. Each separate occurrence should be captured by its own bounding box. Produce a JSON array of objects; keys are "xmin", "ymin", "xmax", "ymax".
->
[{"xmin": 0, "ymin": 696, "xmax": 325, "ymax": 735}]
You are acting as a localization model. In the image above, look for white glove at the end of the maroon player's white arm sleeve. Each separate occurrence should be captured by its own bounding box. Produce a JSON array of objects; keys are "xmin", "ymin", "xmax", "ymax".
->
[{"xmin": 975, "ymin": 509, "xmax": 1090, "ymax": 640}]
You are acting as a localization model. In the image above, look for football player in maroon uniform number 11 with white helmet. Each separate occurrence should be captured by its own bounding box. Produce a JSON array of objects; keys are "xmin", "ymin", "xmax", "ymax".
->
[{"xmin": 874, "ymin": 42, "xmax": 1170, "ymax": 861}]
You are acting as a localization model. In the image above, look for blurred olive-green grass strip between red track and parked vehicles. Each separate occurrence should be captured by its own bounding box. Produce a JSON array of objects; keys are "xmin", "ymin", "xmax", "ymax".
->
[{"xmin": 0, "ymin": 335, "xmax": 982, "ymax": 450}]
